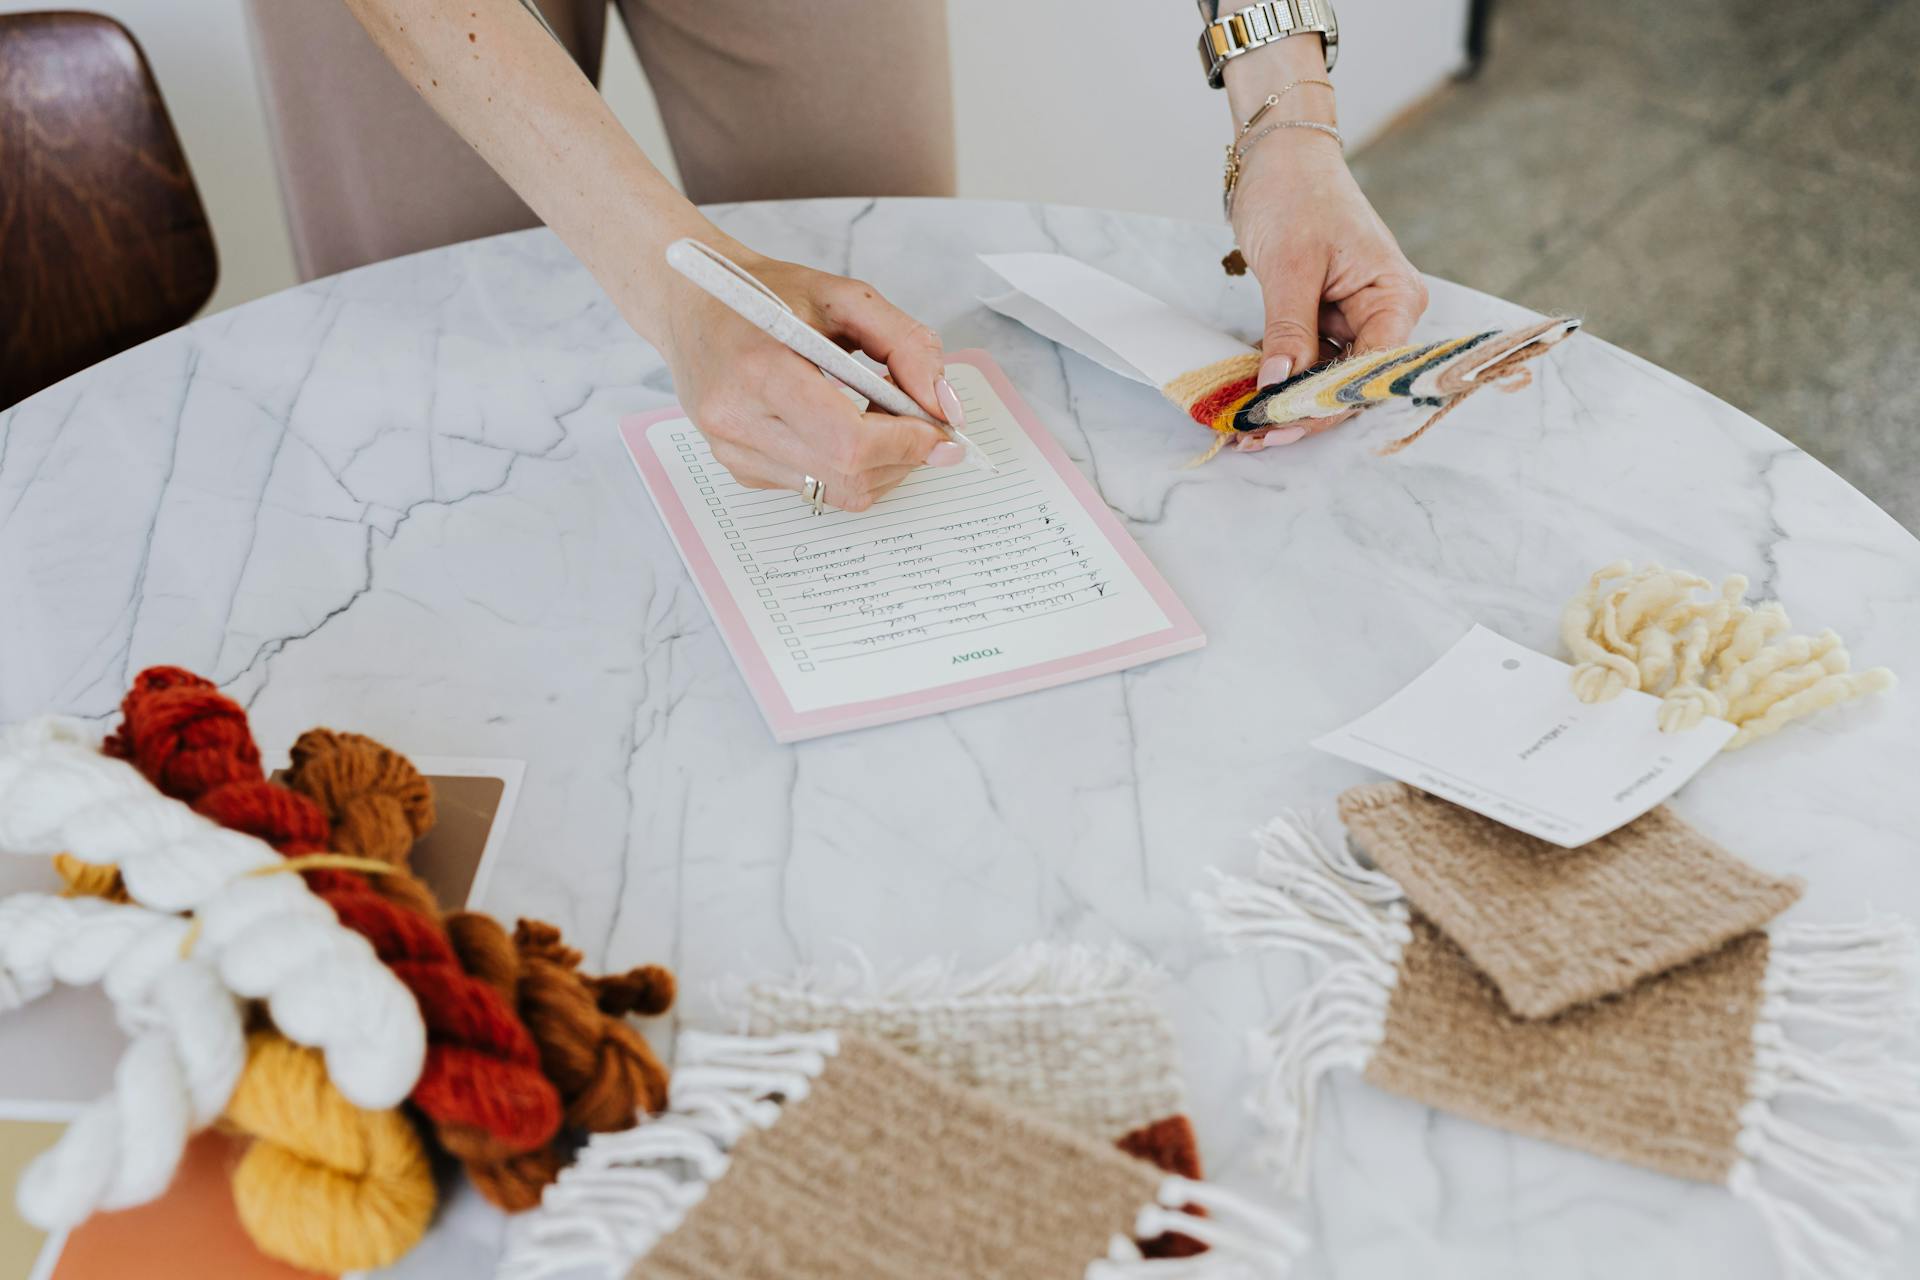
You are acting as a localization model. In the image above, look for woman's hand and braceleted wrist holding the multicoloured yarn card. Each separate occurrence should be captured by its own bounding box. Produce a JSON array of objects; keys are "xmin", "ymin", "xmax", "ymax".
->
[{"xmin": 1227, "ymin": 36, "xmax": 1427, "ymax": 445}]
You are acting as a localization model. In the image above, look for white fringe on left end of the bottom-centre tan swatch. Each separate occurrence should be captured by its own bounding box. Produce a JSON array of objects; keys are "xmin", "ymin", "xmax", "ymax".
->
[{"xmin": 497, "ymin": 1031, "xmax": 839, "ymax": 1280}]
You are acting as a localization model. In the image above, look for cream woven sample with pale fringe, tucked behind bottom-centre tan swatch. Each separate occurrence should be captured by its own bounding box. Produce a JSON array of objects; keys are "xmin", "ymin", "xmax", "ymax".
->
[{"xmin": 735, "ymin": 944, "xmax": 1187, "ymax": 1142}]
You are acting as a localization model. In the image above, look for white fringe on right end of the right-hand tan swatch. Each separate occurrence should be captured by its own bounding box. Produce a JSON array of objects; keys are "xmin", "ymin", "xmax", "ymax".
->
[{"xmin": 1728, "ymin": 919, "xmax": 1920, "ymax": 1280}]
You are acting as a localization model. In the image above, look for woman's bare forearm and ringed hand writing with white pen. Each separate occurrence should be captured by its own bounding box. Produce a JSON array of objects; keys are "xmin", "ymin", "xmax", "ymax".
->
[{"xmin": 348, "ymin": 0, "xmax": 960, "ymax": 510}]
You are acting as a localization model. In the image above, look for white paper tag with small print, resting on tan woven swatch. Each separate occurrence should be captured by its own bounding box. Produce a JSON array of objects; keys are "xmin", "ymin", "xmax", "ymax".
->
[{"xmin": 1313, "ymin": 626, "xmax": 1734, "ymax": 848}]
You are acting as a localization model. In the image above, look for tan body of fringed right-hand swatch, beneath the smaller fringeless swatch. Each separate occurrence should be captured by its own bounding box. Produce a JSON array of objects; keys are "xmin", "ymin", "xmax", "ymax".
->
[{"xmin": 1365, "ymin": 915, "xmax": 1766, "ymax": 1182}]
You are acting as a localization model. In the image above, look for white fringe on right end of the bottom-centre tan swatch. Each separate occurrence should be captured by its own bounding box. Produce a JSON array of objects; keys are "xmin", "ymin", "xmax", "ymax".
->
[{"xmin": 1087, "ymin": 1176, "xmax": 1309, "ymax": 1280}]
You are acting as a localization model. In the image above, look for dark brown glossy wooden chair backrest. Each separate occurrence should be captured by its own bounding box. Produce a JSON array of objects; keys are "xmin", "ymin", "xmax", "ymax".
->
[{"xmin": 0, "ymin": 12, "xmax": 219, "ymax": 407}]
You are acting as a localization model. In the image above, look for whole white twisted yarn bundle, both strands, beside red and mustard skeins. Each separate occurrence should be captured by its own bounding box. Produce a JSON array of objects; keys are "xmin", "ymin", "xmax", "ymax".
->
[{"xmin": 0, "ymin": 718, "xmax": 426, "ymax": 1222}]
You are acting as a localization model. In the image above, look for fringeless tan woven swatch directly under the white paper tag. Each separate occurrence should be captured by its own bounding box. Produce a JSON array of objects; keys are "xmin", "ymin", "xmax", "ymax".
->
[{"xmin": 1340, "ymin": 781, "xmax": 1801, "ymax": 1017}]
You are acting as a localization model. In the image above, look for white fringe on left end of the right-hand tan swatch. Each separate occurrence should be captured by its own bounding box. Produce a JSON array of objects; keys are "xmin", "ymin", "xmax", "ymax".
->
[{"xmin": 1194, "ymin": 814, "xmax": 1413, "ymax": 1196}]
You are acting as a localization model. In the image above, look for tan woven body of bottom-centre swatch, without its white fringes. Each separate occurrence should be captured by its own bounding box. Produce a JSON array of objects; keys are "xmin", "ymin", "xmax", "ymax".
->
[{"xmin": 630, "ymin": 1036, "xmax": 1162, "ymax": 1280}]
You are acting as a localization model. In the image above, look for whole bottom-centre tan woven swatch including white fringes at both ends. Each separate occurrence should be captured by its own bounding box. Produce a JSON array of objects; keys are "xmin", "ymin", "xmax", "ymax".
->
[{"xmin": 501, "ymin": 1031, "xmax": 1302, "ymax": 1280}]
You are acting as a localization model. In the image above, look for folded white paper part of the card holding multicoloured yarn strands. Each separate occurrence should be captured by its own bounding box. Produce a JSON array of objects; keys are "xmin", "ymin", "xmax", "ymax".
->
[{"xmin": 979, "ymin": 253, "xmax": 1252, "ymax": 388}]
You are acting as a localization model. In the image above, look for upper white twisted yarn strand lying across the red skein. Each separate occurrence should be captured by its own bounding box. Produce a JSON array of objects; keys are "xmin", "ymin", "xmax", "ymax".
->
[{"xmin": 0, "ymin": 718, "xmax": 426, "ymax": 1109}]
